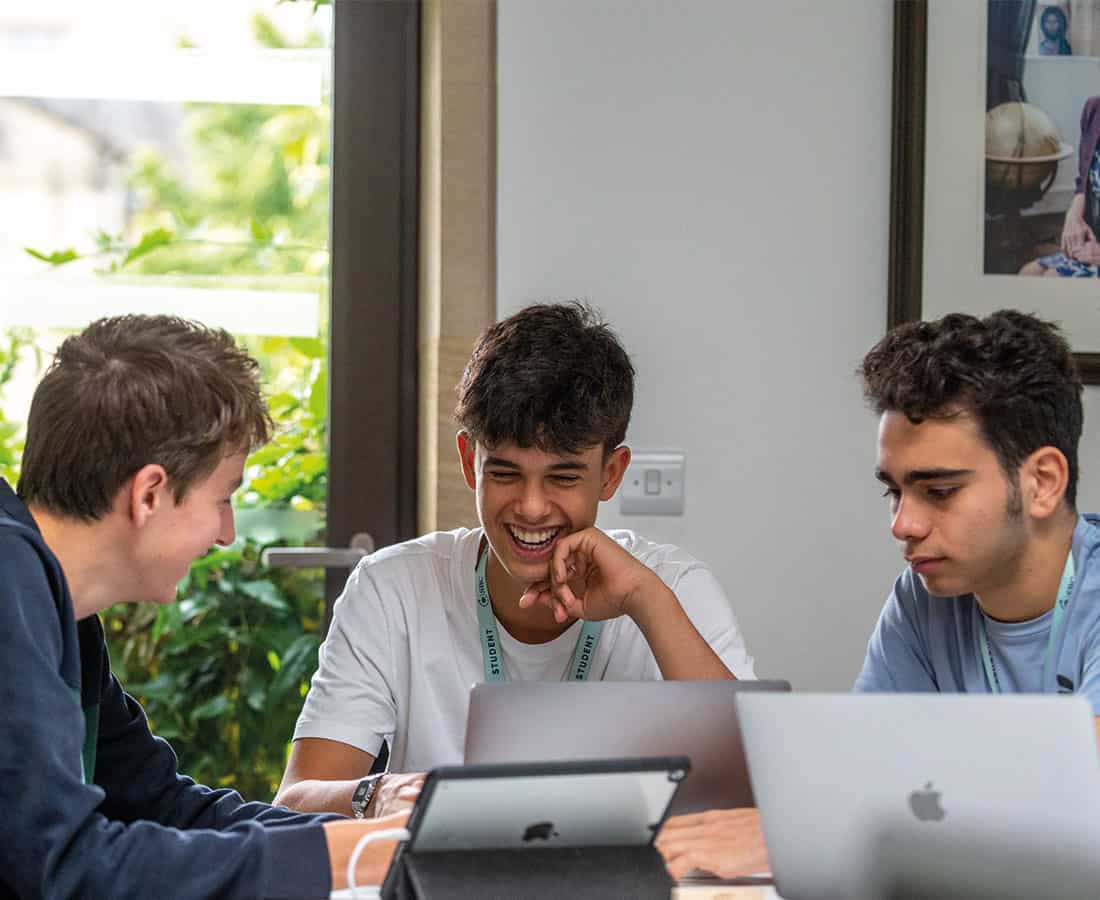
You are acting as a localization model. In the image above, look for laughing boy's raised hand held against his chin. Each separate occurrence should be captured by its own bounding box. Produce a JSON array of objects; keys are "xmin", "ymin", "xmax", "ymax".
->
[{"xmin": 519, "ymin": 528, "xmax": 664, "ymax": 622}]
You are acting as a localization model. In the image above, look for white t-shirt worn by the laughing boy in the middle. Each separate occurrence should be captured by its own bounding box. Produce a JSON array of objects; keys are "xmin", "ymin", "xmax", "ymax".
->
[{"xmin": 294, "ymin": 528, "xmax": 755, "ymax": 772}]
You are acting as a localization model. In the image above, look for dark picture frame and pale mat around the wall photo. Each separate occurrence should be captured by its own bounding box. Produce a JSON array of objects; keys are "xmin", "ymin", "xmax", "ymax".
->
[{"xmin": 887, "ymin": 0, "xmax": 1100, "ymax": 384}]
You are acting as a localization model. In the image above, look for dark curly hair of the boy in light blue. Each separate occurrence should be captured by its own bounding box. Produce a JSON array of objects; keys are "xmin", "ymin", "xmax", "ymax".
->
[{"xmin": 857, "ymin": 309, "xmax": 1084, "ymax": 508}]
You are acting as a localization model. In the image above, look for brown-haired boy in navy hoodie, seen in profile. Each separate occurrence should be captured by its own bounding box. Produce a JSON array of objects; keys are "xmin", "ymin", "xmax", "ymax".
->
[{"xmin": 0, "ymin": 316, "xmax": 404, "ymax": 898}]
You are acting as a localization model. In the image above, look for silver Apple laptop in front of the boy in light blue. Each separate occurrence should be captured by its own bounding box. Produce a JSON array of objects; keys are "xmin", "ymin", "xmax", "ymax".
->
[{"xmin": 737, "ymin": 694, "xmax": 1100, "ymax": 900}]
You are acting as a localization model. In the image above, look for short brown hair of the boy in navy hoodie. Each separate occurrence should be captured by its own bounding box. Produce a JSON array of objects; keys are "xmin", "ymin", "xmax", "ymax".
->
[{"xmin": 18, "ymin": 316, "xmax": 272, "ymax": 522}]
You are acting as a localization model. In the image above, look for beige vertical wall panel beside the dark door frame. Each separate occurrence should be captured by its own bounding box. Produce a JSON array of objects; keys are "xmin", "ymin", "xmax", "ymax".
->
[{"xmin": 419, "ymin": 0, "xmax": 496, "ymax": 531}]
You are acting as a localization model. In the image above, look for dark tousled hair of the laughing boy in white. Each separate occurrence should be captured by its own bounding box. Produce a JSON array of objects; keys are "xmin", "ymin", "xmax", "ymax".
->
[{"xmin": 454, "ymin": 301, "xmax": 634, "ymax": 454}]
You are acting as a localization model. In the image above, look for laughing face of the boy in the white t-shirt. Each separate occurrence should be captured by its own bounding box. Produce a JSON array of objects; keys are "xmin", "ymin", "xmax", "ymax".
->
[{"xmin": 459, "ymin": 432, "xmax": 630, "ymax": 585}]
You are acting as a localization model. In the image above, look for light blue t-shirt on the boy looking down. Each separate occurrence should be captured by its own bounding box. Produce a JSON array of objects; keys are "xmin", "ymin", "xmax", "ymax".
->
[{"xmin": 855, "ymin": 515, "xmax": 1100, "ymax": 715}]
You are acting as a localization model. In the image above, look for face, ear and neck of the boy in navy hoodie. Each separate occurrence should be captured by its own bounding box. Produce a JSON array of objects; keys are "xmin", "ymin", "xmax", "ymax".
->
[{"xmin": 132, "ymin": 453, "xmax": 245, "ymax": 603}]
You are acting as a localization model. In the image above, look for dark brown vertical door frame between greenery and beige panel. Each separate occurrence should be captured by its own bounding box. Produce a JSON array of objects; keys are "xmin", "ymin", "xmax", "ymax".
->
[{"xmin": 326, "ymin": 0, "xmax": 421, "ymax": 616}]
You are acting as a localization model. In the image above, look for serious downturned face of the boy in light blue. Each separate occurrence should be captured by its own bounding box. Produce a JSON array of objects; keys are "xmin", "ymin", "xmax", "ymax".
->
[{"xmin": 876, "ymin": 411, "xmax": 1030, "ymax": 596}]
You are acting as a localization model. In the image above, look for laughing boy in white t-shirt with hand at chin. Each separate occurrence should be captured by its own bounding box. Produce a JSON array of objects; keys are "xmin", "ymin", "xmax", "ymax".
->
[{"xmin": 277, "ymin": 304, "xmax": 754, "ymax": 815}]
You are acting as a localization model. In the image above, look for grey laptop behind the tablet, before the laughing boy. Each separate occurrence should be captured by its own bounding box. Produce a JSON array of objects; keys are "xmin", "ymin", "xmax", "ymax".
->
[{"xmin": 465, "ymin": 681, "xmax": 791, "ymax": 815}]
